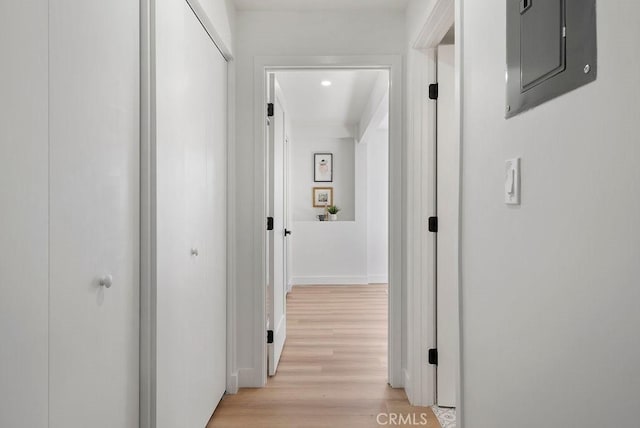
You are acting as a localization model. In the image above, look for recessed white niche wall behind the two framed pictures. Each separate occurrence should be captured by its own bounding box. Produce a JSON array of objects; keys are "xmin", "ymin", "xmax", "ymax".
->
[{"xmin": 290, "ymin": 135, "xmax": 356, "ymax": 222}]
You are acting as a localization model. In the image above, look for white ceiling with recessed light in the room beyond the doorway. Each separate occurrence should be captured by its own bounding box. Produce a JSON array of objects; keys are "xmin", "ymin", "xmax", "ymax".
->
[{"xmin": 276, "ymin": 70, "xmax": 387, "ymax": 125}]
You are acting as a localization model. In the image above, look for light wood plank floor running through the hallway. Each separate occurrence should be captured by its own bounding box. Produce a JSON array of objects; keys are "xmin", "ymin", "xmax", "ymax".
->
[{"xmin": 207, "ymin": 285, "xmax": 440, "ymax": 428}]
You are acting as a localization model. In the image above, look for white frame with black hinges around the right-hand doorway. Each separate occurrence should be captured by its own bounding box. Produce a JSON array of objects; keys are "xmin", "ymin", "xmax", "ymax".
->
[{"xmin": 405, "ymin": 0, "xmax": 463, "ymax": 414}]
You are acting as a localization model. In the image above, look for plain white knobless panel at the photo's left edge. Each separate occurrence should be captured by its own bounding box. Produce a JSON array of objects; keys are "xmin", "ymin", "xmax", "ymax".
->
[{"xmin": 0, "ymin": 0, "xmax": 49, "ymax": 428}]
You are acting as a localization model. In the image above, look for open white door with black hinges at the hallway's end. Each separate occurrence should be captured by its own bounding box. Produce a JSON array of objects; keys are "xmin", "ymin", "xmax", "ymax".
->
[{"xmin": 267, "ymin": 74, "xmax": 287, "ymax": 376}]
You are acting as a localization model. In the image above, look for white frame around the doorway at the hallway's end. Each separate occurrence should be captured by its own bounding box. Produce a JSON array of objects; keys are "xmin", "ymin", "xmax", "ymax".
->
[{"xmin": 253, "ymin": 55, "xmax": 404, "ymax": 387}]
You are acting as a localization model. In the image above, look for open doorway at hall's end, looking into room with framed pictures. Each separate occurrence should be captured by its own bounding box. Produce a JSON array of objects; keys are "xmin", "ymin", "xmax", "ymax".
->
[{"xmin": 266, "ymin": 69, "xmax": 389, "ymax": 385}]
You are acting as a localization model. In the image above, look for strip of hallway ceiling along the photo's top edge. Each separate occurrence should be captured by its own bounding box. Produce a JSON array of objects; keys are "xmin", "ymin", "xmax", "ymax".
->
[{"xmin": 234, "ymin": 0, "xmax": 409, "ymax": 10}]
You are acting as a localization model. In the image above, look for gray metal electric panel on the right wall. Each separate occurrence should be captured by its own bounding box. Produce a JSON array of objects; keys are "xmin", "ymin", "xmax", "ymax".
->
[{"xmin": 505, "ymin": 0, "xmax": 597, "ymax": 118}]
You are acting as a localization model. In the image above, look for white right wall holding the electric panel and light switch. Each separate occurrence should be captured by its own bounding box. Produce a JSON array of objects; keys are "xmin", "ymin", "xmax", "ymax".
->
[{"xmin": 457, "ymin": 0, "xmax": 640, "ymax": 428}]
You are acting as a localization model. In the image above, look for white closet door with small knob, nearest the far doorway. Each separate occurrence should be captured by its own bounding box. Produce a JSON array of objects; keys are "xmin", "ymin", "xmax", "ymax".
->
[{"xmin": 155, "ymin": 0, "xmax": 227, "ymax": 422}]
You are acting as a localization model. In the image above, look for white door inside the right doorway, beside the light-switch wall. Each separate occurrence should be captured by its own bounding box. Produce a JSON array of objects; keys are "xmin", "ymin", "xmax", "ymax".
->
[{"xmin": 436, "ymin": 45, "xmax": 460, "ymax": 407}]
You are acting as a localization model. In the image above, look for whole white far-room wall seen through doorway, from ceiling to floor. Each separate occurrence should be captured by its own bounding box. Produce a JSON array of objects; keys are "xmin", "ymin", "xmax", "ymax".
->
[{"xmin": 291, "ymin": 112, "xmax": 389, "ymax": 285}]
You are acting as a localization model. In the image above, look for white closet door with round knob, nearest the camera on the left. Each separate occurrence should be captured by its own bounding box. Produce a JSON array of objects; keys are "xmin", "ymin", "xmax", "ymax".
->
[{"xmin": 49, "ymin": 0, "xmax": 140, "ymax": 428}]
